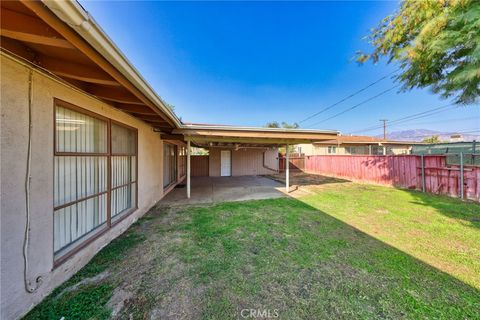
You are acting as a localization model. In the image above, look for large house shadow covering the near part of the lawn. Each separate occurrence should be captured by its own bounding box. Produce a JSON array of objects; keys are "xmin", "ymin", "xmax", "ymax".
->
[{"xmin": 21, "ymin": 194, "xmax": 480, "ymax": 319}]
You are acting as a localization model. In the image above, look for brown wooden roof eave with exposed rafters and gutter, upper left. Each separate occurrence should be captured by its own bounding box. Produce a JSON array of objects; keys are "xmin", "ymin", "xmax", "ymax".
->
[{"xmin": 0, "ymin": 1, "xmax": 181, "ymax": 132}]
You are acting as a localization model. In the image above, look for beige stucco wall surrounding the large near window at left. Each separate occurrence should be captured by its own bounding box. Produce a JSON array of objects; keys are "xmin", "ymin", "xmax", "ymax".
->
[{"xmin": 0, "ymin": 54, "xmax": 163, "ymax": 319}]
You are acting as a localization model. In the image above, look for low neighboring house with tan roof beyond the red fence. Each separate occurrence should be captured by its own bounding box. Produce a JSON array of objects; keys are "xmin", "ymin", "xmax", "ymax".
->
[{"xmin": 297, "ymin": 135, "xmax": 418, "ymax": 156}]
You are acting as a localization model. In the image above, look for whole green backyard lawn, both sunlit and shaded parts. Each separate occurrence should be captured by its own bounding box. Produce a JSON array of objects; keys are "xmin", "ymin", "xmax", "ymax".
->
[{"xmin": 27, "ymin": 182, "xmax": 480, "ymax": 319}]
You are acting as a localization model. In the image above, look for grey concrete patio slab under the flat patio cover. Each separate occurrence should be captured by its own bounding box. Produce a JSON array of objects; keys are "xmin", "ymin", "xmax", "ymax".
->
[{"xmin": 159, "ymin": 176, "xmax": 286, "ymax": 206}]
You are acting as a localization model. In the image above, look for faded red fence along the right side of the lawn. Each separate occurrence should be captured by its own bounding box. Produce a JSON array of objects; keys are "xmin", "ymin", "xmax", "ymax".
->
[{"xmin": 304, "ymin": 155, "xmax": 480, "ymax": 201}]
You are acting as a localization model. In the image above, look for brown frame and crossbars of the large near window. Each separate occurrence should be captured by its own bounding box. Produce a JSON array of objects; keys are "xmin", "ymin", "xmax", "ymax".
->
[{"xmin": 52, "ymin": 98, "xmax": 139, "ymax": 268}]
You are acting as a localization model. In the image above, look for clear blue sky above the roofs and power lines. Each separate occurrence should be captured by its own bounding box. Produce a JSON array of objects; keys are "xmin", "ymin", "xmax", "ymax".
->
[{"xmin": 81, "ymin": 1, "xmax": 480, "ymax": 135}]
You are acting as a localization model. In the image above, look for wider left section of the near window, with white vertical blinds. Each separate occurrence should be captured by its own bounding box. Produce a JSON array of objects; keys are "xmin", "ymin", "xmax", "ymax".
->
[{"xmin": 53, "ymin": 105, "xmax": 108, "ymax": 252}]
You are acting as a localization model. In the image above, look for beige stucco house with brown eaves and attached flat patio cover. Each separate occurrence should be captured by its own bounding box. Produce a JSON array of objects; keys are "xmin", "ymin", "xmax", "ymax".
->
[{"xmin": 0, "ymin": 1, "xmax": 337, "ymax": 319}]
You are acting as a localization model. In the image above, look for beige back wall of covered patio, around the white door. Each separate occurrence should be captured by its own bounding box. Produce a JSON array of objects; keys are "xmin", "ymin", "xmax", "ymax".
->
[{"xmin": 209, "ymin": 148, "xmax": 278, "ymax": 177}]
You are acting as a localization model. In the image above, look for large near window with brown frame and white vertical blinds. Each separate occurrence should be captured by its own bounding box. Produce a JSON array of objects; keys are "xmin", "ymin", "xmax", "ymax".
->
[{"xmin": 53, "ymin": 101, "xmax": 137, "ymax": 258}]
